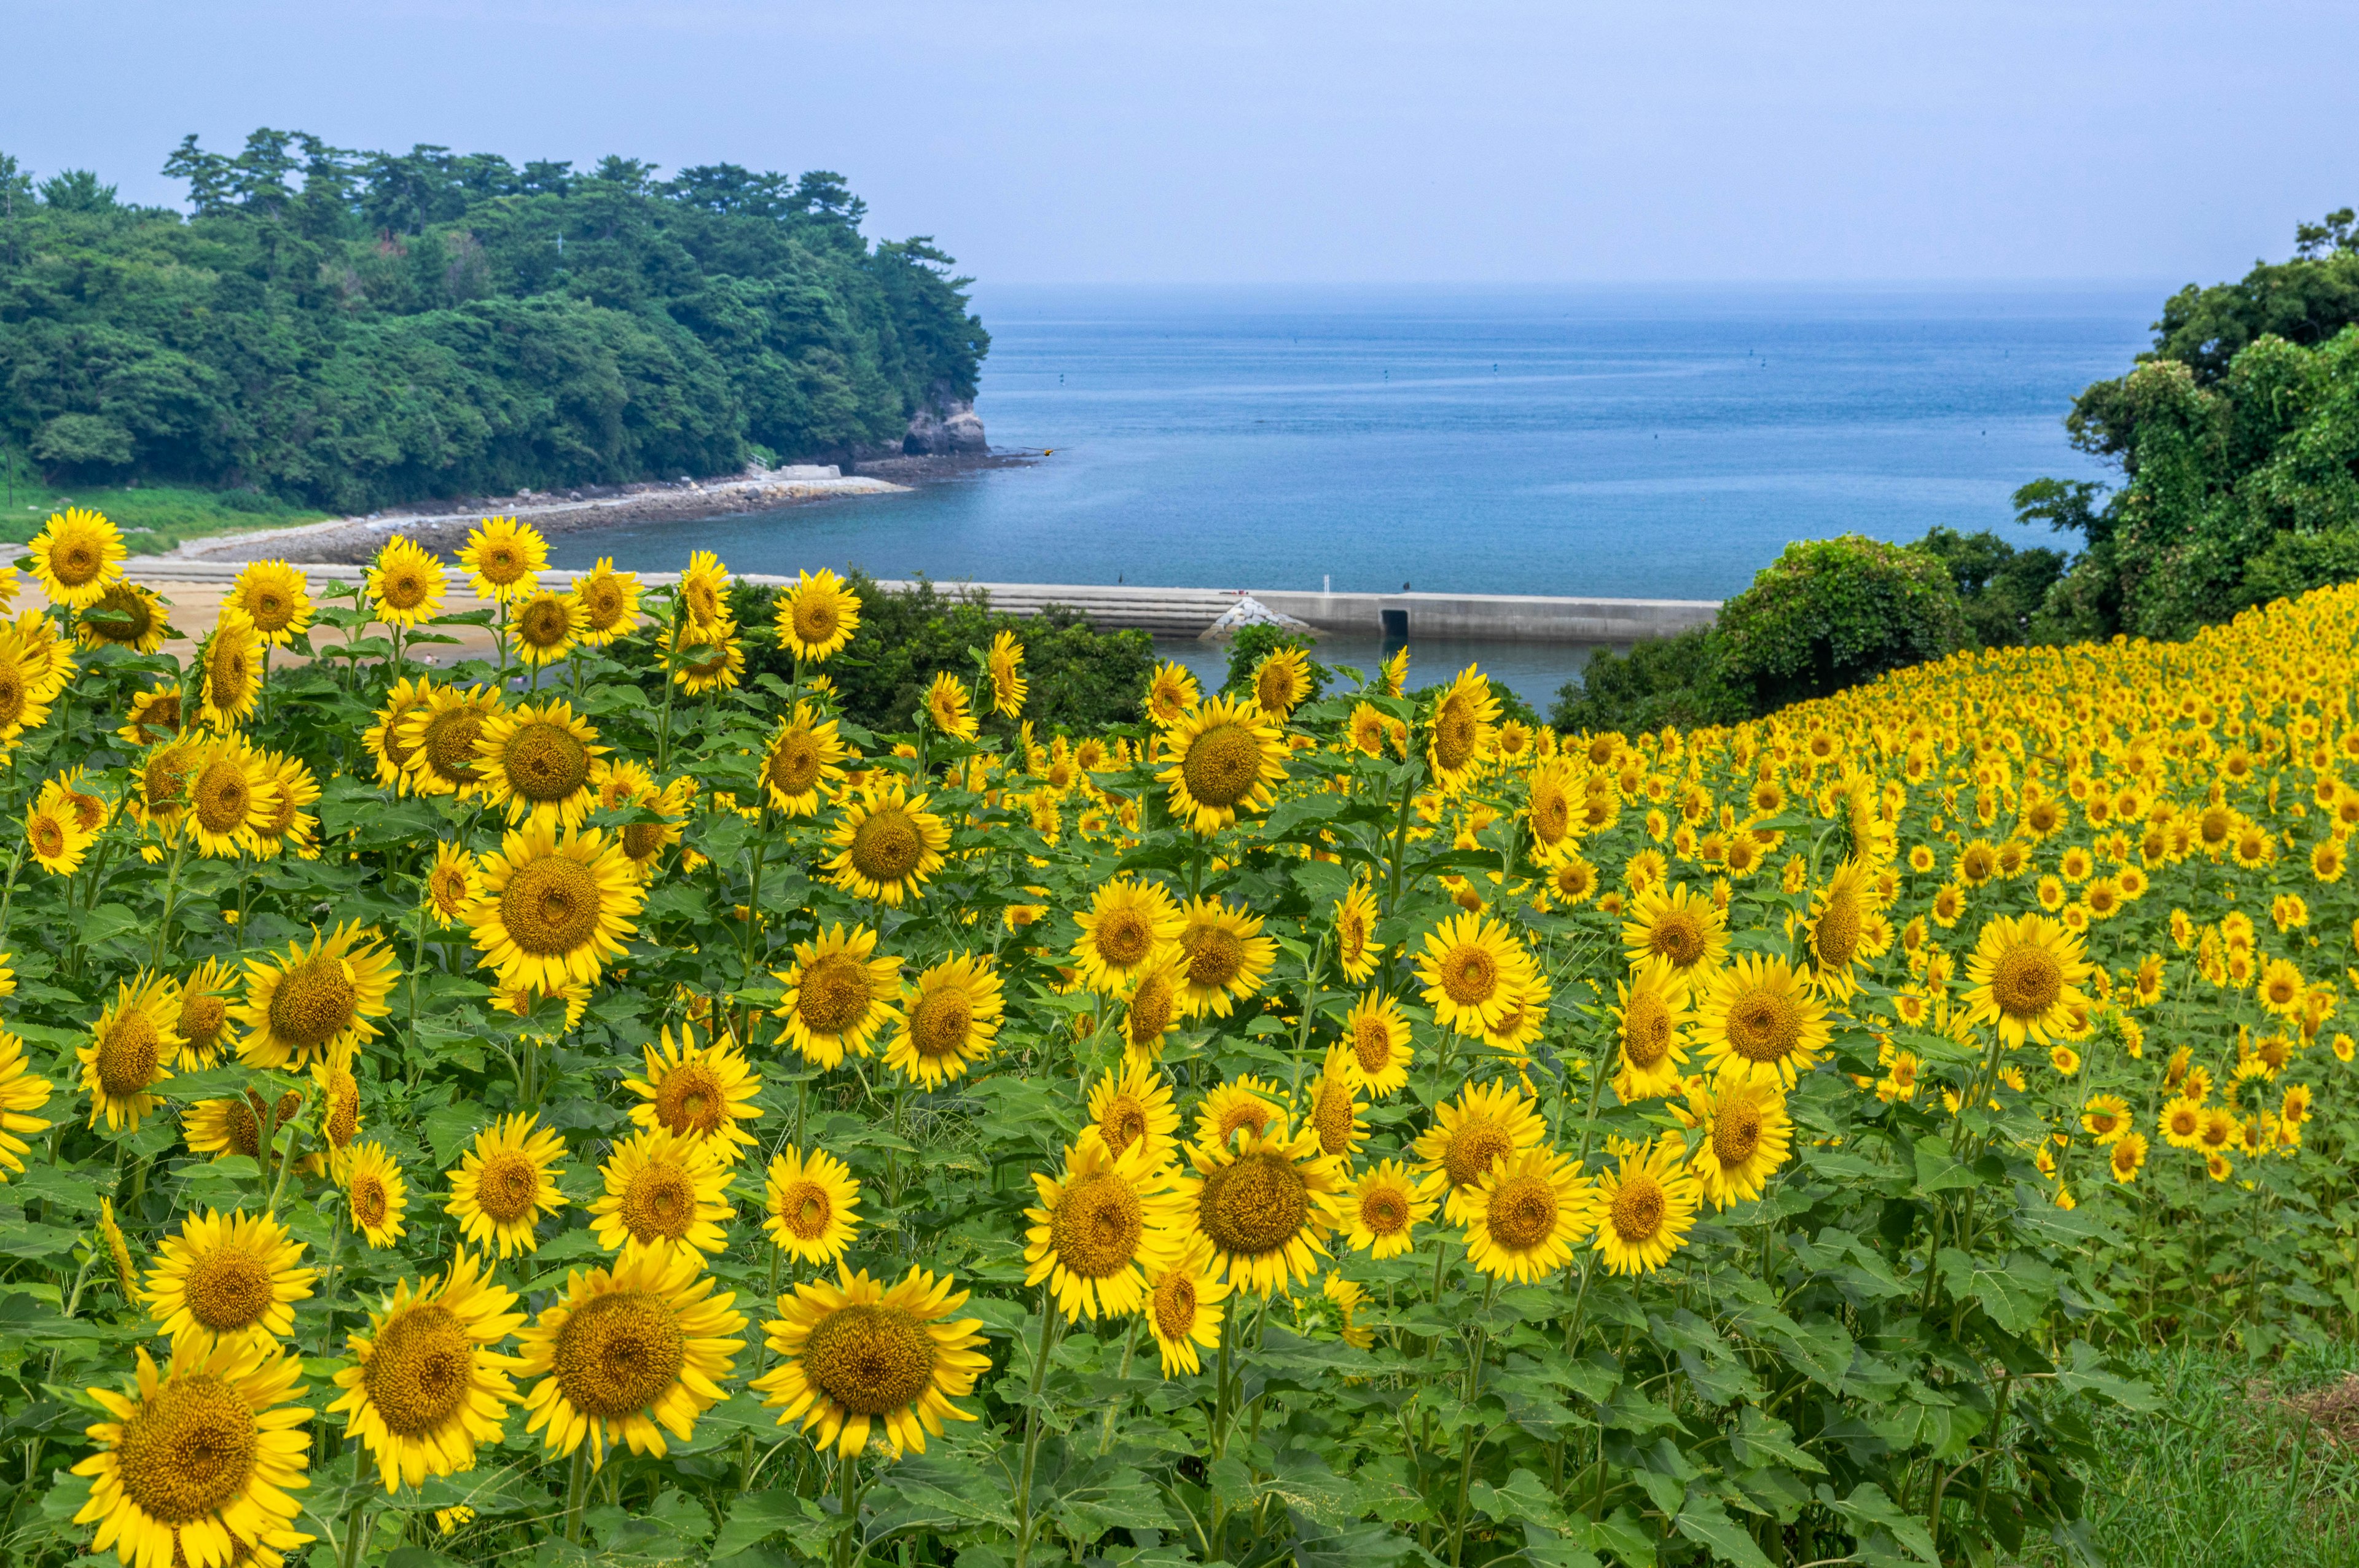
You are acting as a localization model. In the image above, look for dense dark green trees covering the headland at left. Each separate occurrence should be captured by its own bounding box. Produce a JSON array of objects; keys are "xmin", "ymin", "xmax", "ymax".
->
[{"xmin": 0, "ymin": 130, "xmax": 988, "ymax": 512}]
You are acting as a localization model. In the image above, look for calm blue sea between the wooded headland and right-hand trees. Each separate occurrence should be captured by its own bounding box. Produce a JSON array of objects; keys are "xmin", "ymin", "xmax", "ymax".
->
[{"xmin": 552, "ymin": 283, "xmax": 2165, "ymax": 698}]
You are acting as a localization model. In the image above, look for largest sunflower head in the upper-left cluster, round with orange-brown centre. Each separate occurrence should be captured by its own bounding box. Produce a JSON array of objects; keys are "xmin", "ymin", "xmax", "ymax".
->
[{"xmin": 469, "ymin": 821, "xmax": 646, "ymax": 993}]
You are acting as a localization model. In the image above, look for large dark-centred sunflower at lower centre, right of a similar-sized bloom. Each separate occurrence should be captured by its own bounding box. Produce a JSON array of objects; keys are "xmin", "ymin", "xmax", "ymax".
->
[{"xmin": 1189, "ymin": 1118, "xmax": 1345, "ymax": 1295}]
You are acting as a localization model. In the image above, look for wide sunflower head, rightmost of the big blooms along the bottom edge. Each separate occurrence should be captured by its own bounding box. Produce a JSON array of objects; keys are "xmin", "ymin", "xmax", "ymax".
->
[{"xmin": 748, "ymin": 1264, "xmax": 991, "ymax": 1459}]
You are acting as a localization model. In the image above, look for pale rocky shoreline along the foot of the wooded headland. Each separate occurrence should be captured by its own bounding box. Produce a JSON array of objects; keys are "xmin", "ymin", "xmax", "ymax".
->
[{"xmin": 157, "ymin": 450, "xmax": 1033, "ymax": 566}]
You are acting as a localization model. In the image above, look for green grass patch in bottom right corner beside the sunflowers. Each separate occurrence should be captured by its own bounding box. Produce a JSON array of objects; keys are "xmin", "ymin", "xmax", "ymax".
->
[{"xmin": 2050, "ymin": 1344, "xmax": 2359, "ymax": 1568}]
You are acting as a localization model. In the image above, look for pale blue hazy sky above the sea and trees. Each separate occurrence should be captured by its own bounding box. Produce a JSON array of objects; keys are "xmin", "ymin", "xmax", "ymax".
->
[{"xmin": 0, "ymin": 0, "xmax": 2359, "ymax": 283}]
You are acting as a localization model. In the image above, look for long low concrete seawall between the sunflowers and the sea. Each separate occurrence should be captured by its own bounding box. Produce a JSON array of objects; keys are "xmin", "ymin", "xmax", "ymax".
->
[{"xmin": 125, "ymin": 556, "xmax": 1719, "ymax": 646}]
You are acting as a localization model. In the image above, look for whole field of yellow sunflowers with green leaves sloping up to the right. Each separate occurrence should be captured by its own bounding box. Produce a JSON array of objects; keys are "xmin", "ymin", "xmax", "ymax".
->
[{"xmin": 0, "ymin": 512, "xmax": 2359, "ymax": 1568}]
